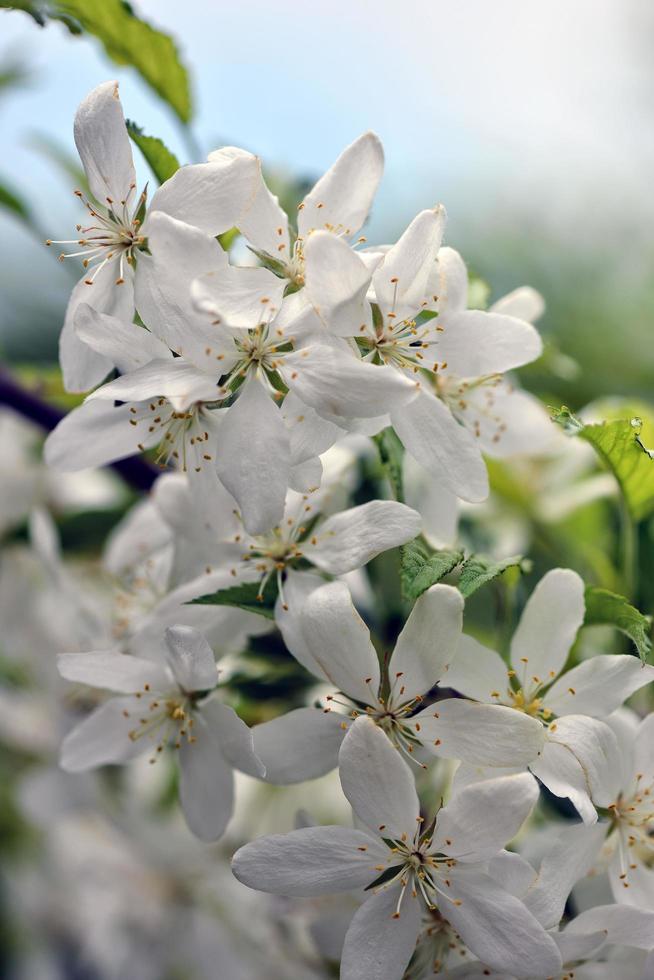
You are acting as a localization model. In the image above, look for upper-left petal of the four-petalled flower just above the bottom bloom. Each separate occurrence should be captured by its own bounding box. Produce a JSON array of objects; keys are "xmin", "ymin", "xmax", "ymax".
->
[{"xmin": 300, "ymin": 582, "xmax": 379, "ymax": 704}]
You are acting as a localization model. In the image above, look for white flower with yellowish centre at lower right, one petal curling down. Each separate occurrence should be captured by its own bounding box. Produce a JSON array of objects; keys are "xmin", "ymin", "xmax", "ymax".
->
[{"xmin": 448, "ymin": 568, "xmax": 654, "ymax": 822}]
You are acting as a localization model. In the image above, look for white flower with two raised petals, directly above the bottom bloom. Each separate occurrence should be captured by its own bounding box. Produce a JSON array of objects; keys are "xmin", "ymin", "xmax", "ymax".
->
[{"xmin": 254, "ymin": 582, "xmax": 544, "ymax": 783}]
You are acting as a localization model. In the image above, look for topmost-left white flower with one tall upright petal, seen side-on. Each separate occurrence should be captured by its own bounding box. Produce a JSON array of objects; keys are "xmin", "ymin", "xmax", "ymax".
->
[{"xmin": 48, "ymin": 81, "xmax": 259, "ymax": 391}]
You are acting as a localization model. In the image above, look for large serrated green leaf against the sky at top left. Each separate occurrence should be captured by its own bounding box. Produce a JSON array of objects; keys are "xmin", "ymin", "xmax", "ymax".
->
[{"xmin": 53, "ymin": 0, "xmax": 192, "ymax": 122}]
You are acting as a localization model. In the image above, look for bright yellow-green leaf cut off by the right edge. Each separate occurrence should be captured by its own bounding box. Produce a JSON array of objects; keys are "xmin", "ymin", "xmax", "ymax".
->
[{"xmin": 552, "ymin": 406, "xmax": 654, "ymax": 521}]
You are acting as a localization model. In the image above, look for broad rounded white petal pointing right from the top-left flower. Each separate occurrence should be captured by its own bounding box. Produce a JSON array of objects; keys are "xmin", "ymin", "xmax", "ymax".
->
[{"xmin": 150, "ymin": 147, "xmax": 259, "ymax": 235}]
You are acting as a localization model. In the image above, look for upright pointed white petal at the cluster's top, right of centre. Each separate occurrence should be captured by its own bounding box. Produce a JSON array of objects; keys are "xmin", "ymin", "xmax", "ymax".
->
[{"xmin": 298, "ymin": 133, "xmax": 384, "ymax": 238}]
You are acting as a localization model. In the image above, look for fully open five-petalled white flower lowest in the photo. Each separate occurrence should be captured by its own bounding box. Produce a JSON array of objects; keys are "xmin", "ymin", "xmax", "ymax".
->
[{"xmin": 233, "ymin": 718, "xmax": 561, "ymax": 980}]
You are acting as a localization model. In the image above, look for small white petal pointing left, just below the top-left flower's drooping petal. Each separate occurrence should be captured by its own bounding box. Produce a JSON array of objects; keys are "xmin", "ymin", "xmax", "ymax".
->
[{"xmin": 75, "ymin": 303, "xmax": 170, "ymax": 374}]
